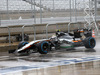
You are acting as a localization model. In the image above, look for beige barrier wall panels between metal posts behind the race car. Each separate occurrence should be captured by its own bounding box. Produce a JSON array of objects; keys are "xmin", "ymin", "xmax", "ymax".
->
[{"xmin": 0, "ymin": 23, "xmax": 84, "ymax": 43}]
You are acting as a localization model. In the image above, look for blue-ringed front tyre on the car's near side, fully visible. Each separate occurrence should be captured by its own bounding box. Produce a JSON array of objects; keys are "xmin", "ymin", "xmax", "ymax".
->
[{"xmin": 38, "ymin": 41, "xmax": 50, "ymax": 54}]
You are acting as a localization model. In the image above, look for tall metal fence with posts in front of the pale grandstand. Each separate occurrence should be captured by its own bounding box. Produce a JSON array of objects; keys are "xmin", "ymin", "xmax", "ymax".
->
[{"xmin": 0, "ymin": 0, "xmax": 100, "ymax": 43}]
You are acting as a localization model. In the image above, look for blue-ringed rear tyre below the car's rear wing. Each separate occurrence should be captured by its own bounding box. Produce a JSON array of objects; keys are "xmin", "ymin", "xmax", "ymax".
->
[{"xmin": 84, "ymin": 37, "xmax": 96, "ymax": 48}]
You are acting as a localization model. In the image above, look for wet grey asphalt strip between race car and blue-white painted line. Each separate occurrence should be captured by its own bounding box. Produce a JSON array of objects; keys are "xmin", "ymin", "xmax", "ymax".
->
[{"xmin": 0, "ymin": 37, "xmax": 100, "ymax": 68}]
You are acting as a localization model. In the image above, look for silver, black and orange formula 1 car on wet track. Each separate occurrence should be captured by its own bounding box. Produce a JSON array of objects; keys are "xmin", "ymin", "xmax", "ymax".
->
[{"xmin": 9, "ymin": 29, "xmax": 96, "ymax": 55}]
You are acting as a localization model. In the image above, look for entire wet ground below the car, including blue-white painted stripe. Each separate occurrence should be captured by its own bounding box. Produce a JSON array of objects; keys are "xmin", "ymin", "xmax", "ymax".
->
[{"xmin": 0, "ymin": 37, "xmax": 100, "ymax": 75}]
